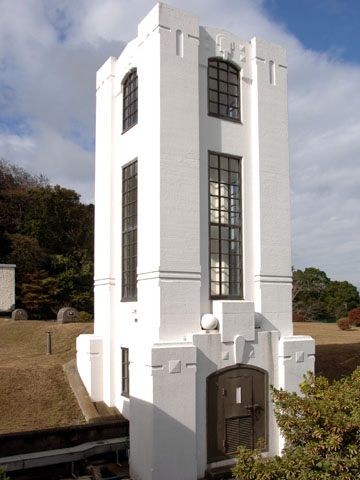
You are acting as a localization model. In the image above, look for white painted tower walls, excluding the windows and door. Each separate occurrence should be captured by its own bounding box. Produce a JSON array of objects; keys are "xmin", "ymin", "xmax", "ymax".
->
[{"xmin": 77, "ymin": 4, "xmax": 314, "ymax": 480}]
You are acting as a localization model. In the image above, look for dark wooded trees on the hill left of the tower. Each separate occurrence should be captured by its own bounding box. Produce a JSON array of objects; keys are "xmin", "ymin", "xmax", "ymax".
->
[{"xmin": 0, "ymin": 160, "xmax": 94, "ymax": 319}]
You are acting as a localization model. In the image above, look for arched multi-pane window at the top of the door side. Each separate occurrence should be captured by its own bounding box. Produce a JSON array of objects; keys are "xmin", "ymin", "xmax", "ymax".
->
[{"xmin": 208, "ymin": 58, "xmax": 240, "ymax": 122}]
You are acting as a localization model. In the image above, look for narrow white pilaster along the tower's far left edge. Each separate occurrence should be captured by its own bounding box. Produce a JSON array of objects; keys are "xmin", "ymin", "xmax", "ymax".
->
[{"xmin": 94, "ymin": 57, "xmax": 116, "ymax": 405}]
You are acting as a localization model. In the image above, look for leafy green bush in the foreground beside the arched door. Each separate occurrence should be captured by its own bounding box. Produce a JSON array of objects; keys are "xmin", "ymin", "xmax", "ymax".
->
[{"xmin": 233, "ymin": 367, "xmax": 360, "ymax": 480}]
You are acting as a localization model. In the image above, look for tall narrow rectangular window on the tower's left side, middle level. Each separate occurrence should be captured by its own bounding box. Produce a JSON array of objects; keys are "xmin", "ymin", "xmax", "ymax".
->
[{"xmin": 121, "ymin": 161, "xmax": 137, "ymax": 301}]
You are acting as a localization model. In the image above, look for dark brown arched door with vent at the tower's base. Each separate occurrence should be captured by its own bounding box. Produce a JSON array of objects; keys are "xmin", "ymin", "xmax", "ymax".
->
[{"xmin": 206, "ymin": 364, "xmax": 268, "ymax": 463}]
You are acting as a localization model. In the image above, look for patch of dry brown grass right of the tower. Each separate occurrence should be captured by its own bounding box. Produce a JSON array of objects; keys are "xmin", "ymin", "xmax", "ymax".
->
[{"xmin": 294, "ymin": 322, "xmax": 360, "ymax": 380}]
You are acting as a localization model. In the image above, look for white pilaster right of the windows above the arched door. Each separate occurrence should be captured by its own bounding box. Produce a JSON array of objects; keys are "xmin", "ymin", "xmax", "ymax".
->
[{"xmin": 251, "ymin": 38, "xmax": 292, "ymax": 335}]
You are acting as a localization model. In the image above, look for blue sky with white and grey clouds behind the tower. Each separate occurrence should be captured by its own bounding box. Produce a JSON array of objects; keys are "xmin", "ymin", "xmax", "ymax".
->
[{"xmin": 0, "ymin": 0, "xmax": 360, "ymax": 287}]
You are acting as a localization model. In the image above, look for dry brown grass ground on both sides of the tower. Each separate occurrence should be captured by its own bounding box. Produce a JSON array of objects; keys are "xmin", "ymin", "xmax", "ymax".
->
[{"xmin": 0, "ymin": 319, "xmax": 360, "ymax": 433}]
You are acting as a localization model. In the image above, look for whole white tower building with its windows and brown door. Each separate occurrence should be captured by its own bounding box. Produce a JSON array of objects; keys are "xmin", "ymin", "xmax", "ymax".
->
[{"xmin": 77, "ymin": 3, "xmax": 314, "ymax": 480}]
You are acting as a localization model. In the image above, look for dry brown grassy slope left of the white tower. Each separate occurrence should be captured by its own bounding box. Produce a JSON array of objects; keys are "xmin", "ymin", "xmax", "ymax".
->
[{"xmin": 0, "ymin": 319, "xmax": 93, "ymax": 433}]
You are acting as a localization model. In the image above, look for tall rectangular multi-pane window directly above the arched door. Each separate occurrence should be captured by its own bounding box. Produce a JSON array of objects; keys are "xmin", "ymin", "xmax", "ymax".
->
[{"xmin": 209, "ymin": 152, "xmax": 243, "ymax": 299}]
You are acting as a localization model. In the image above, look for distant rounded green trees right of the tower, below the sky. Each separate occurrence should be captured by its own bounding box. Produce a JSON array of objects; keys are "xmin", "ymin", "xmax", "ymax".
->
[{"xmin": 293, "ymin": 267, "xmax": 360, "ymax": 321}]
